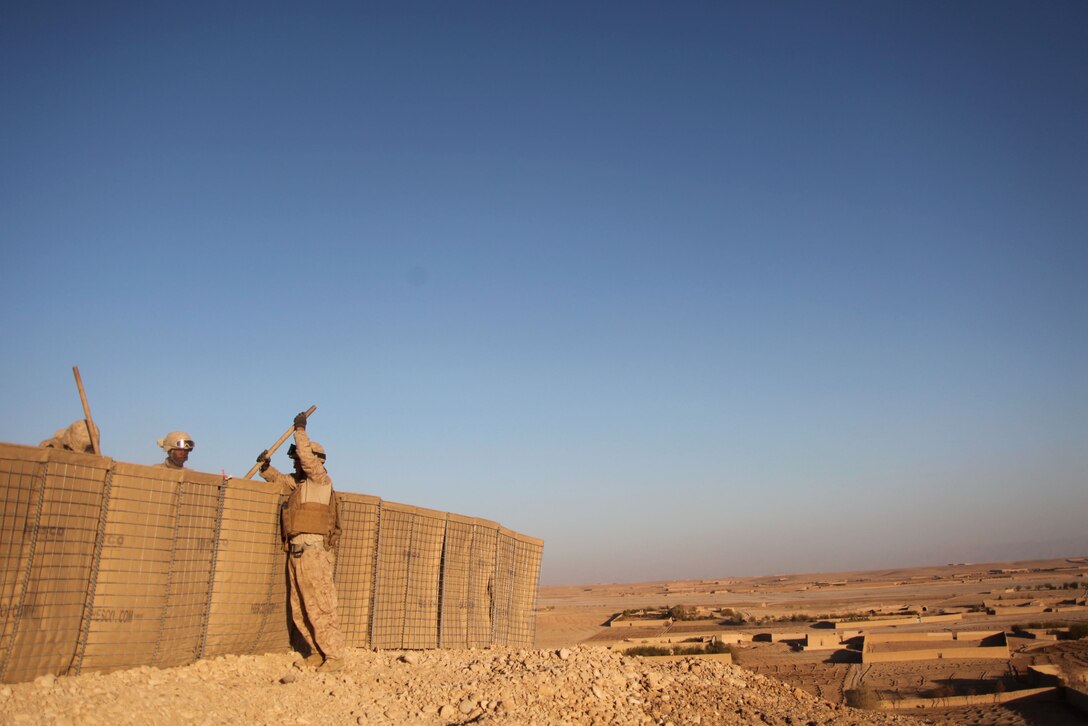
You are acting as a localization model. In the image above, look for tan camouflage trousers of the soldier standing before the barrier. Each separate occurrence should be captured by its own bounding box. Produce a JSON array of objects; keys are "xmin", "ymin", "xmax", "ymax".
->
[{"xmin": 287, "ymin": 544, "xmax": 344, "ymax": 657}]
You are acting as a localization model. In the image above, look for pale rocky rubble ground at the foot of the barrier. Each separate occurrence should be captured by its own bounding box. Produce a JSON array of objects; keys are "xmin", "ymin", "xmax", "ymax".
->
[{"xmin": 0, "ymin": 647, "xmax": 926, "ymax": 726}]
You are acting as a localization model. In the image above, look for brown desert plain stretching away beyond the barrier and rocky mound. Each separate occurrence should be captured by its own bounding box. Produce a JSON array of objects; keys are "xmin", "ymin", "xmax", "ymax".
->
[{"xmin": 536, "ymin": 557, "xmax": 1088, "ymax": 725}]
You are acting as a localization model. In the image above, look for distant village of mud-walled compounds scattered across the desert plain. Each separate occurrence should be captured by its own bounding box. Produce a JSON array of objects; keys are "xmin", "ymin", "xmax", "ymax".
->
[{"xmin": 552, "ymin": 557, "xmax": 1088, "ymax": 709}]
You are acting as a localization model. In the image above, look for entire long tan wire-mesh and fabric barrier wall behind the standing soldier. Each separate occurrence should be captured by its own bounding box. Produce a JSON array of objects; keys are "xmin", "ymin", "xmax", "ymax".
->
[{"xmin": 0, "ymin": 444, "xmax": 544, "ymax": 682}]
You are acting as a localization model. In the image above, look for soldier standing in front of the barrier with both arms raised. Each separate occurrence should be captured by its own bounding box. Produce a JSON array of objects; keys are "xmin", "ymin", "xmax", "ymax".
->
[{"xmin": 257, "ymin": 413, "xmax": 344, "ymax": 673}]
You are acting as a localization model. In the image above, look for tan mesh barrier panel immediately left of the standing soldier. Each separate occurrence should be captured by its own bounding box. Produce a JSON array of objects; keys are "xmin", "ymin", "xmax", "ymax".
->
[{"xmin": 202, "ymin": 479, "xmax": 289, "ymax": 657}]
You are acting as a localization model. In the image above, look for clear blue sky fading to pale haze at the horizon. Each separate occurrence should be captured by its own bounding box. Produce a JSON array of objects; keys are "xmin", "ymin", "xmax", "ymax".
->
[{"xmin": 0, "ymin": 0, "xmax": 1088, "ymax": 585}]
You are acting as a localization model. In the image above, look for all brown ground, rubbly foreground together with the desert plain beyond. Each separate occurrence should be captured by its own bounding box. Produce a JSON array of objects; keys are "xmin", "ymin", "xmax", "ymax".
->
[{"xmin": 0, "ymin": 559, "xmax": 1088, "ymax": 726}]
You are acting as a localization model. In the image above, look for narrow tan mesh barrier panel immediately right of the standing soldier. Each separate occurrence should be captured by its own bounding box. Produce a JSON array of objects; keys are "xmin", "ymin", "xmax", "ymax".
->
[{"xmin": 334, "ymin": 493, "xmax": 381, "ymax": 648}]
